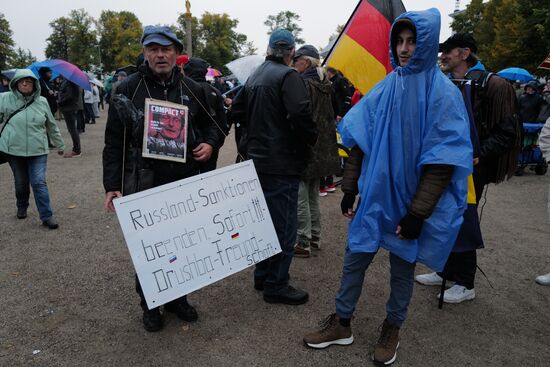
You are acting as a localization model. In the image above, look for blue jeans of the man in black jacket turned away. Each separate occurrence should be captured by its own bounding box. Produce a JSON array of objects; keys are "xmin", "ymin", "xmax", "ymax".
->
[{"xmin": 254, "ymin": 174, "xmax": 298, "ymax": 295}]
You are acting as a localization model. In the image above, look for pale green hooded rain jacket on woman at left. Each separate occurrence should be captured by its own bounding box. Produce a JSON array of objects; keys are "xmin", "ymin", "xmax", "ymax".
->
[{"xmin": 0, "ymin": 69, "xmax": 65, "ymax": 157}]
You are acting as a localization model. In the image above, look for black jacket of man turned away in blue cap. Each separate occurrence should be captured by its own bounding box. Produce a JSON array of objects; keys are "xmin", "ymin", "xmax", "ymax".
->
[{"xmin": 232, "ymin": 56, "xmax": 317, "ymax": 176}]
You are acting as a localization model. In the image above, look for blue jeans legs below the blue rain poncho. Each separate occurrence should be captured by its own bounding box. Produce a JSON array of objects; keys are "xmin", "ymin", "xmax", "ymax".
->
[{"xmin": 336, "ymin": 248, "xmax": 416, "ymax": 327}]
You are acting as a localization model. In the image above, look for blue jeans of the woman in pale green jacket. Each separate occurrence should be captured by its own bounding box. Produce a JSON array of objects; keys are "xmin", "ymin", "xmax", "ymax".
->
[{"xmin": 9, "ymin": 154, "xmax": 53, "ymax": 221}]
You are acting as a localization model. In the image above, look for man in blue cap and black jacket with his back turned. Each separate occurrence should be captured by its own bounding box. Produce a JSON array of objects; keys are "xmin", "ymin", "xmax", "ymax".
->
[{"xmin": 232, "ymin": 29, "xmax": 317, "ymax": 305}]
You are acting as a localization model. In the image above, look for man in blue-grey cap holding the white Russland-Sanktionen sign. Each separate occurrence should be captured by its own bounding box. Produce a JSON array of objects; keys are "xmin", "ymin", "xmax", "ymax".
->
[{"xmin": 103, "ymin": 26, "xmax": 221, "ymax": 331}]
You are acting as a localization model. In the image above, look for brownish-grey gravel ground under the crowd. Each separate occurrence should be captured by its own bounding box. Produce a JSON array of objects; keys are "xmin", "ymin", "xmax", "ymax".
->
[{"xmin": 0, "ymin": 112, "xmax": 550, "ymax": 367}]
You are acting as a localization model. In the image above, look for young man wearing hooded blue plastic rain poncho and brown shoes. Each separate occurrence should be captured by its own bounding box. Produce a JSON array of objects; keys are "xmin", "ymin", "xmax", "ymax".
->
[{"xmin": 304, "ymin": 9, "xmax": 473, "ymax": 364}]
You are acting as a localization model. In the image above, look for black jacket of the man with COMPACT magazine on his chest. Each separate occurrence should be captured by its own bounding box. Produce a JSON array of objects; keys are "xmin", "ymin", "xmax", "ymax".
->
[{"xmin": 103, "ymin": 64, "xmax": 221, "ymax": 193}]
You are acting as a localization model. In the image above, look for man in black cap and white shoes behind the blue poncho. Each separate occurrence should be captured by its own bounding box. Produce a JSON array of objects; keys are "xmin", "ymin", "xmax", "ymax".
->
[{"xmin": 415, "ymin": 33, "xmax": 521, "ymax": 303}]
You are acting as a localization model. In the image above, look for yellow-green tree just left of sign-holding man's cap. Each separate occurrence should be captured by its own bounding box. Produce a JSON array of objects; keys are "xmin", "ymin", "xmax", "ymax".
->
[{"xmin": 97, "ymin": 10, "xmax": 143, "ymax": 70}]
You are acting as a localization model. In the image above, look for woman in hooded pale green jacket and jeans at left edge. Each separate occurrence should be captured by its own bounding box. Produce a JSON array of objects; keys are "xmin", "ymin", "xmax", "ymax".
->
[{"xmin": 0, "ymin": 69, "xmax": 65, "ymax": 229}]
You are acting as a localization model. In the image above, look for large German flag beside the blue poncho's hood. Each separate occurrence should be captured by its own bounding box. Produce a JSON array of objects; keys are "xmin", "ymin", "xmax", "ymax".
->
[{"xmin": 325, "ymin": 0, "xmax": 405, "ymax": 94}]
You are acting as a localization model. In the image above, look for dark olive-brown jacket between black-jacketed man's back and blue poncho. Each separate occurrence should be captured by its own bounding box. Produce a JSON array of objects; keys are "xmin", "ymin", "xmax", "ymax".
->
[{"xmin": 301, "ymin": 68, "xmax": 340, "ymax": 179}]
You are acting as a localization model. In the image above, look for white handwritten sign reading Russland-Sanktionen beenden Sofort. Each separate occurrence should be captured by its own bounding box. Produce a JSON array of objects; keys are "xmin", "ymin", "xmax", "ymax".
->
[{"xmin": 114, "ymin": 161, "xmax": 281, "ymax": 309}]
